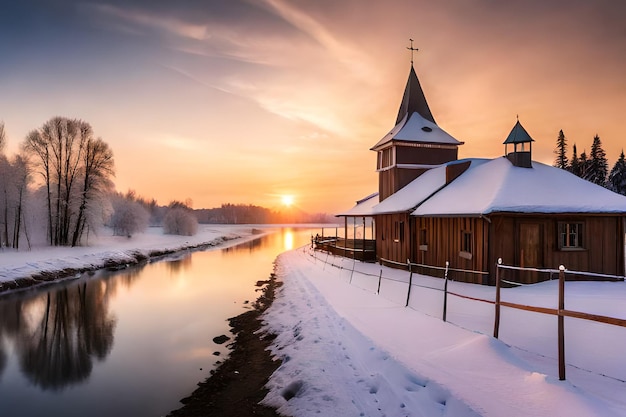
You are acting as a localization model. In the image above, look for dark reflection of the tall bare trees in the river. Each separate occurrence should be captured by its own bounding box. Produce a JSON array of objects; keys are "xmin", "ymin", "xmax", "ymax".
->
[{"xmin": 0, "ymin": 281, "xmax": 115, "ymax": 390}]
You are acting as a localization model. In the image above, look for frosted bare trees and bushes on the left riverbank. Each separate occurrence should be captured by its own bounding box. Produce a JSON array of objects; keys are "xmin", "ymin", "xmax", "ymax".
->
[{"xmin": 0, "ymin": 117, "xmax": 198, "ymax": 249}]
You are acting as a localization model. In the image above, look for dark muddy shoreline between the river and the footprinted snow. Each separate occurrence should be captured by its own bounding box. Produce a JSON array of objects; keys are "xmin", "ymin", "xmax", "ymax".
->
[{"xmin": 168, "ymin": 274, "xmax": 282, "ymax": 417}]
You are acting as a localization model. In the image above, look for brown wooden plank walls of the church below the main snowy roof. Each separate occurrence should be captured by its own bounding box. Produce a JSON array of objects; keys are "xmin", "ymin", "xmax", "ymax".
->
[{"xmin": 376, "ymin": 213, "xmax": 626, "ymax": 285}]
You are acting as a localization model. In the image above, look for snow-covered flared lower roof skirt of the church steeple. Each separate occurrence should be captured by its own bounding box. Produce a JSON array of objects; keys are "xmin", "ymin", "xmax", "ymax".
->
[{"xmin": 371, "ymin": 112, "xmax": 463, "ymax": 150}]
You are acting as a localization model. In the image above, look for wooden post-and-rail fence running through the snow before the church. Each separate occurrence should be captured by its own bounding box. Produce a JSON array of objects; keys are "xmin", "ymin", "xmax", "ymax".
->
[{"xmin": 312, "ymin": 247, "xmax": 626, "ymax": 380}]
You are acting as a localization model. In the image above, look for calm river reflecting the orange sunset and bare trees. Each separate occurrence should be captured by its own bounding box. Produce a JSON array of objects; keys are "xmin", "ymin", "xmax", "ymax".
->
[{"xmin": 0, "ymin": 228, "xmax": 316, "ymax": 417}]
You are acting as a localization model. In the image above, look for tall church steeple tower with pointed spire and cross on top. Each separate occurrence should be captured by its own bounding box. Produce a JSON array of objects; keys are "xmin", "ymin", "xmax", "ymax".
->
[{"xmin": 370, "ymin": 44, "xmax": 463, "ymax": 201}]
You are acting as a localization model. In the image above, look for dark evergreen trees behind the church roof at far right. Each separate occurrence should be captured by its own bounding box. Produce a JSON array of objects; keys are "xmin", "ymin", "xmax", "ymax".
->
[{"xmin": 553, "ymin": 130, "xmax": 626, "ymax": 195}]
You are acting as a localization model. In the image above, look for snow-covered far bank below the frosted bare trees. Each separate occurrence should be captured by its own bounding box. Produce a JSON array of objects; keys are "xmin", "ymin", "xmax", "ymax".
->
[{"xmin": 0, "ymin": 225, "xmax": 266, "ymax": 284}]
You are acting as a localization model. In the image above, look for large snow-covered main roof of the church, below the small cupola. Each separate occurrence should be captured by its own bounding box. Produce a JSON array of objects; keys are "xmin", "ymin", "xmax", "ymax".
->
[{"xmin": 407, "ymin": 157, "xmax": 626, "ymax": 216}]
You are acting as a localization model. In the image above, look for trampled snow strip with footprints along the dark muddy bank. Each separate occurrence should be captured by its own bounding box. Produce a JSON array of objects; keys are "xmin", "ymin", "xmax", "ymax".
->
[{"xmin": 266, "ymin": 250, "xmax": 476, "ymax": 417}]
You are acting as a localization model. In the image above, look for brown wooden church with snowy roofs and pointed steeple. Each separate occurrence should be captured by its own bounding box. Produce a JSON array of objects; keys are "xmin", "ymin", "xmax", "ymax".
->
[{"xmin": 338, "ymin": 48, "xmax": 626, "ymax": 285}]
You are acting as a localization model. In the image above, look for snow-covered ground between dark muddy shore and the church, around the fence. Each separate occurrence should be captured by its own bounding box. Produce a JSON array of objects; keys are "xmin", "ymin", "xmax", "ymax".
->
[{"xmin": 264, "ymin": 248, "xmax": 626, "ymax": 417}]
